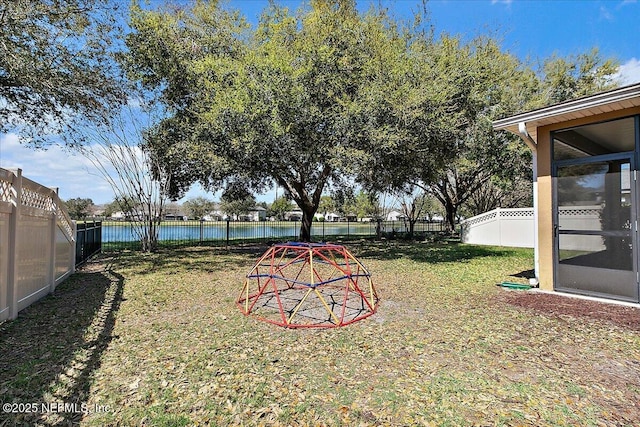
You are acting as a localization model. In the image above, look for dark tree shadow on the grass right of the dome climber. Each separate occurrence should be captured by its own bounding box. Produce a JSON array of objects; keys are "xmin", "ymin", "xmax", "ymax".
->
[{"xmin": 352, "ymin": 241, "xmax": 512, "ymax": 264}]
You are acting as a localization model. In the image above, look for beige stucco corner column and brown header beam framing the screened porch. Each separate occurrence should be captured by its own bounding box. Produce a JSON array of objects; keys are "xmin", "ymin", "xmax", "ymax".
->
[{"xmin": 537, "ymin": 108, "xmax": 640, "ymax": 291}]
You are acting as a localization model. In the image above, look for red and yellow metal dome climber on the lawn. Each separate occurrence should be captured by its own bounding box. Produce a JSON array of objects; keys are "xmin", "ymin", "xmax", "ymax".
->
[{"xmin": 236, "ymin": 242, "xmax": 379, "ymax": 328}]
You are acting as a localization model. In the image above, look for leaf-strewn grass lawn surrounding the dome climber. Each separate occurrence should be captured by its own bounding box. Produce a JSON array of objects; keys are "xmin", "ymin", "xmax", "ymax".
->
[{"xmin": 0, "ymin": 242, "xmax": 640, "ymax": 426}]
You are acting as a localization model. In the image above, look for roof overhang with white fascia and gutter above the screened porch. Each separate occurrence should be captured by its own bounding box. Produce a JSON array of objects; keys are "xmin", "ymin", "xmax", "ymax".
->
[{"xmin": 493, "ymin": 83, "xmax": 640, "ymax": 139}]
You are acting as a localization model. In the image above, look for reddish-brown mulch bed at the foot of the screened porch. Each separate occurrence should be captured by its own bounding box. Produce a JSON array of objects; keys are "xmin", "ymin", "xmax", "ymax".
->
[{"xmin": 498, "ymin": 290, "xmax": 640, "ymax": 331}]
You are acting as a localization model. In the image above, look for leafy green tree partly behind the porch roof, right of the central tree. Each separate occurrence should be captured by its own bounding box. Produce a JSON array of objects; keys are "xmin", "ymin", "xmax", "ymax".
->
[{"xmin": 412, "ymin": 42, "xmax": 616, "ymax": 230}]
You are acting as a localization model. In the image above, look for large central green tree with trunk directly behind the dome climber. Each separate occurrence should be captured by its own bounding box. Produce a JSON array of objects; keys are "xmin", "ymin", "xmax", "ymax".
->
[{"xmin": 127, "ymin": 0, "xmax": 457, "ymax": 240}]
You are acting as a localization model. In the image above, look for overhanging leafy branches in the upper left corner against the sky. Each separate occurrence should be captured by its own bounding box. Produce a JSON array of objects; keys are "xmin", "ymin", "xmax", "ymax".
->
[{"xmin": 0, "ymin": 0, "xmax": 126, "ymax": 145}]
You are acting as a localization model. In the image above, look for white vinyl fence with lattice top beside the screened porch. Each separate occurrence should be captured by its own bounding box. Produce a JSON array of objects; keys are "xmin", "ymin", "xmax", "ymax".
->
[{"xmin": 460, "ymin": 208, "xmax": 535, "ymax": 248}]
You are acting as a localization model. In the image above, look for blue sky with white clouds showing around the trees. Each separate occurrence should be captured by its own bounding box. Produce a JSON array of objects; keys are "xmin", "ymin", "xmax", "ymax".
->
[{"xmin": 0, "ymin": 0, "xmax": 640, "ymax": 204}]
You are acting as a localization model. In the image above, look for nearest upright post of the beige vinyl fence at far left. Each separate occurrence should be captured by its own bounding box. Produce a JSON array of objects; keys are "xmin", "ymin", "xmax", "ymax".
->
[{"xmin": 7, "ymin": 169, "xmax": 22, "ymax": 320}]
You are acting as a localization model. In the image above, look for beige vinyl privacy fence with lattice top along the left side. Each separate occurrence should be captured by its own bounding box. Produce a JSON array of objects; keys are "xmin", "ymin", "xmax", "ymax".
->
[{"xmin": 0, "ymin": 168, "xmax": 76, "ymax": 321}]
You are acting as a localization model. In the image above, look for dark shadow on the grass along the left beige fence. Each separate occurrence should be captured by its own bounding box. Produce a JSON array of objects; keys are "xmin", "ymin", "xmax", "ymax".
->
[{"xmin": 0, "ymin": 265, "xmax": 124, "ymax": 426}]
